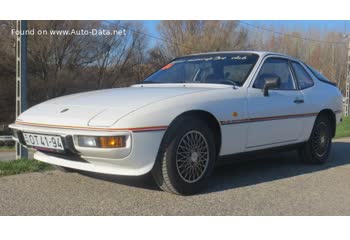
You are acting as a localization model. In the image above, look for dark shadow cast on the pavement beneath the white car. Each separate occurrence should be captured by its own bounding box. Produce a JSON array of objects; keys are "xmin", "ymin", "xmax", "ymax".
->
[{"xmin": 80, "ymin": 141, "xmax": 350, "ymax": 194}]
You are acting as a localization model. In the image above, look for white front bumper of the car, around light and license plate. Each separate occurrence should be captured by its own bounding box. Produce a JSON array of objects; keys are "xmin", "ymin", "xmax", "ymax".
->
[{"xmin": 10, "ymin": 124, "xmax": 165, "ymax": 176}]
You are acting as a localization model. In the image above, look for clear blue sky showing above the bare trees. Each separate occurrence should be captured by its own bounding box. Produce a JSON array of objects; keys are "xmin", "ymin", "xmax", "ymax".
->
[{"xmin": 143, "ymin": 20, "xmax": 350, "ymax": 45}]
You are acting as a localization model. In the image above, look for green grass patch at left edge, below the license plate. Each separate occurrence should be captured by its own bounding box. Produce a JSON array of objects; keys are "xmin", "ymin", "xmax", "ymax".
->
[{"xmin": 0, "ymin": 159, "xmax": 55, "ymax": 177}]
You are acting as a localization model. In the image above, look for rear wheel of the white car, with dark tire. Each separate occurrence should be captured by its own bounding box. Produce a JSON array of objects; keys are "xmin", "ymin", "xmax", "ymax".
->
[{"xmin": 299, "ymin": 115, "xmax": 332, "ymax": 164}]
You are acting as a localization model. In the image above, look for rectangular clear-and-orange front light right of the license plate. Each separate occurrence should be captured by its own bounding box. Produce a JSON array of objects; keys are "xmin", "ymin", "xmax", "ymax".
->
[{"xmin": 78, "ymin": 136, "xmax": 126, "ymax": 148}]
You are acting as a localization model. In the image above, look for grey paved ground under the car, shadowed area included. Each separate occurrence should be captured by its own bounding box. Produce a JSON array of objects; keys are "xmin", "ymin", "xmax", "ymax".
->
[{"xmin": 0, "ymin": 139, "xmax": 350, "ymax": 215}]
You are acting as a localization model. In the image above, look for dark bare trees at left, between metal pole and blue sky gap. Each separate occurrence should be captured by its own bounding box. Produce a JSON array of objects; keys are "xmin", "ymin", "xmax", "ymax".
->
[{"xmin": 28, "ymin": 21, "xmax": 146, "ymax": 99}]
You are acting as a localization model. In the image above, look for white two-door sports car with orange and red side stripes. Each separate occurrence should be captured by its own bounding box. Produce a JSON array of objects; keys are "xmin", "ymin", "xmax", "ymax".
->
[{"xmin": 10, "ymin": 51, "xmax": 342, "ymax": 194}]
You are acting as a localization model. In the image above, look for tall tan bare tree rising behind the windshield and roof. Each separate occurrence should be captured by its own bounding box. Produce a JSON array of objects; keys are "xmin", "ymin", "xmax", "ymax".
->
[{"xmin": 158, "ymin": 20, "xmax": 247, "ymax": 58}]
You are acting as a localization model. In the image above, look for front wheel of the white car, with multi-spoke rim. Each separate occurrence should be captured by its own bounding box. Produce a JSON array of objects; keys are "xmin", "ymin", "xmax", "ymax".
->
[{"xmin": 152, "ymin": 117, "xmax": 217, "ymax": 195}]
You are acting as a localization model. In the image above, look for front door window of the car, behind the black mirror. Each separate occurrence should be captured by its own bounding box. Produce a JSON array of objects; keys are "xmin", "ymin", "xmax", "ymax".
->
[{"xmin": 253, "ymin": 58, "xmax": 296, "ymax": 90}]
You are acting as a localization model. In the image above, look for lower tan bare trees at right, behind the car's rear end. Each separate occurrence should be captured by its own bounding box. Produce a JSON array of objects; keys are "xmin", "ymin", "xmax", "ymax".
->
[{"xmin": 248, "ymin": 22, "xmax": 347, "ymax": 93}]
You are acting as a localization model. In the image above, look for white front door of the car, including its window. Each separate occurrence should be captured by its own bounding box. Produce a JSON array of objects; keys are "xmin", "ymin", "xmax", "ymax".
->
[{"xmin": 246, "ymin": 57, "xmax": 304, "ymax": 149}]
